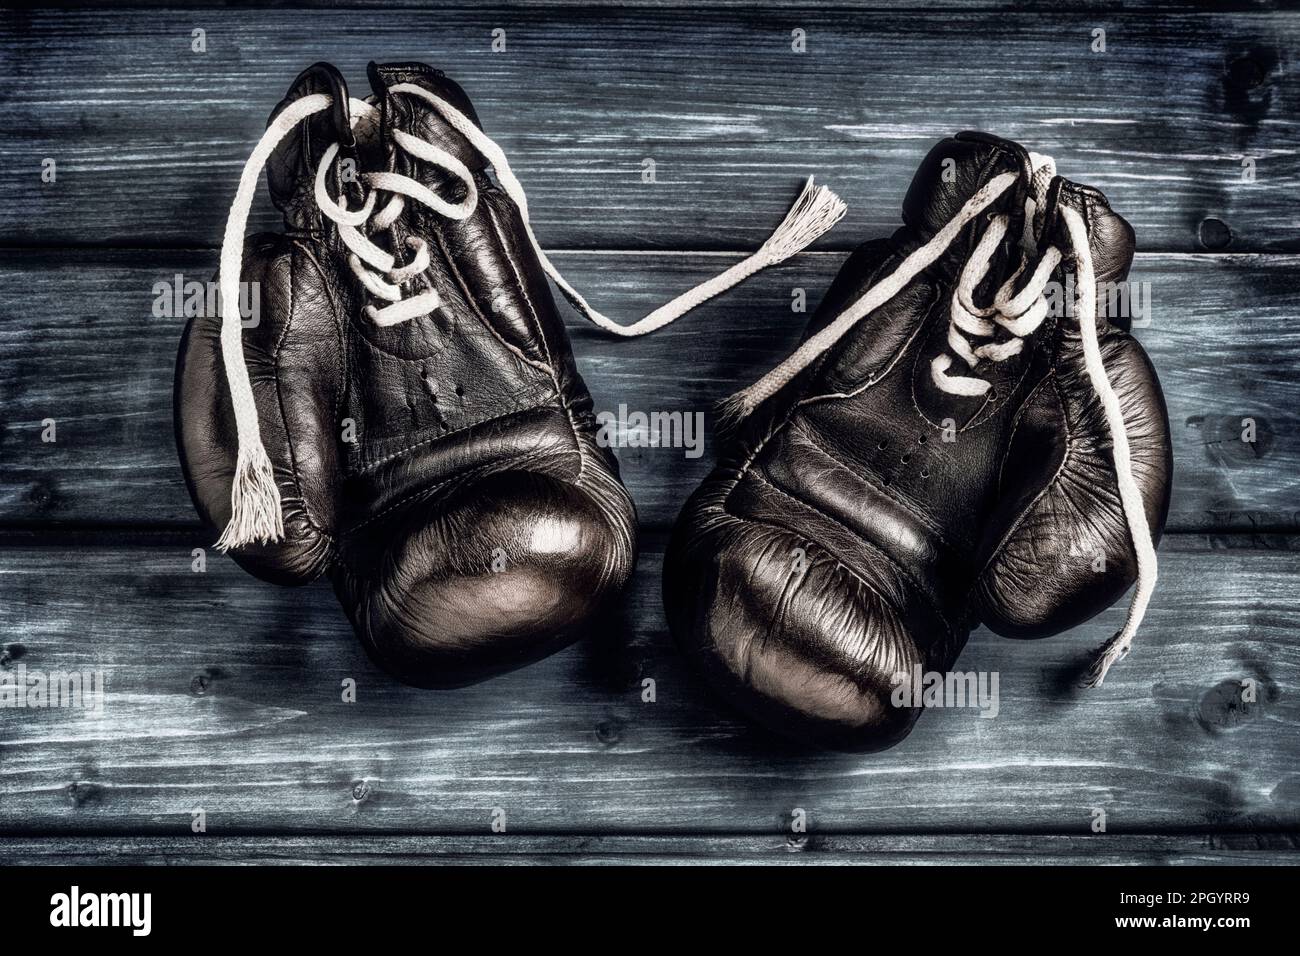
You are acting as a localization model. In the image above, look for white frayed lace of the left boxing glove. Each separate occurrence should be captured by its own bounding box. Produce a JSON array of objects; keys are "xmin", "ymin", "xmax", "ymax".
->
[{"xmin": 217, "ymin": 83, "xmax": 846, "ymax": 550}]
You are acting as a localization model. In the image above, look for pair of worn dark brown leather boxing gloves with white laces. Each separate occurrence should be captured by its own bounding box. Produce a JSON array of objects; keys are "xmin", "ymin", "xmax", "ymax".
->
[{"xmin": 176, "ymin": 64, "xmax": 1171, "ymax": 750}]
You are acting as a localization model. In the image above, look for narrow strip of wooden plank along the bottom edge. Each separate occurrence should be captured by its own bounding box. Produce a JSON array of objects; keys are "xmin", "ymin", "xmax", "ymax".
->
[{"xmin": 0, "ymin": 834, "xmax": 1297, "ymax": 866}]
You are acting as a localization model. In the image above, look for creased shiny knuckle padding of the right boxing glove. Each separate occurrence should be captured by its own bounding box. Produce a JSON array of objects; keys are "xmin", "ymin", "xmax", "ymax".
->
[{"xmin": 664, "ymin": 481, "xmax": 965, "ymax": 752}]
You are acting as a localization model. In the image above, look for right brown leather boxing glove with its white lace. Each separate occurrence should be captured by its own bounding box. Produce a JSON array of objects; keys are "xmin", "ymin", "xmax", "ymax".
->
[{"xmin": 664, "ymin": 133, "xmax": 1171, "ymax": 750}]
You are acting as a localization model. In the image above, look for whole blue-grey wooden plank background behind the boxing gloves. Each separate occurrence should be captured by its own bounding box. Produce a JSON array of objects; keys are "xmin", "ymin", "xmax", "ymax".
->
[{"xmin": 0, "ymin": 0, "xmax": 1300, "ymax": 862}]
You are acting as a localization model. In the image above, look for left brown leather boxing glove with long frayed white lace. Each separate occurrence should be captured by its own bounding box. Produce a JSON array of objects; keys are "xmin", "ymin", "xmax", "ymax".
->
[{"xmin": 176, "ymin": 64, "xmax": 842, "ymax": 687}]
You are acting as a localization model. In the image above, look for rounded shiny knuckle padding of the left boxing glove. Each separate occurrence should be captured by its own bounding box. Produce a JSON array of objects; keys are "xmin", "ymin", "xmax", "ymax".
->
[{"xmin": 335, "ymin": 470, "xmax": 633, "ymax": 687}]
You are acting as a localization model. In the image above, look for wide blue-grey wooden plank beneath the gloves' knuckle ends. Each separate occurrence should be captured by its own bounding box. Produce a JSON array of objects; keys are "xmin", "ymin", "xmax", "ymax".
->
[{"xmin": 0, "ymin": 535, "xmax": 1300, "ymax": 839}]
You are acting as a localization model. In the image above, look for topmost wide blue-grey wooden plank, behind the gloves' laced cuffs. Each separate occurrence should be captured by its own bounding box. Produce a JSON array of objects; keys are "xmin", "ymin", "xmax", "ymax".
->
[{"xmin": 0, "ymin": 7, "xmax": 1300, "ymax": 251}]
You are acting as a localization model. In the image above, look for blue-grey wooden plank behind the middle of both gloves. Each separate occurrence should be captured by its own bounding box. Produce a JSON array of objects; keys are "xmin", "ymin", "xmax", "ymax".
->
[{"xmin": 0, "ymin": 251, "xmax": 1300, "ymax": 531}]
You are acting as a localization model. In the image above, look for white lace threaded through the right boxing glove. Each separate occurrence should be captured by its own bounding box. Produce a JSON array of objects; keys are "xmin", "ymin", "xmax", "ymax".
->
[{"xmin": 722, "ymin": 155, "xmax": 1157, "ymax": 687}]
